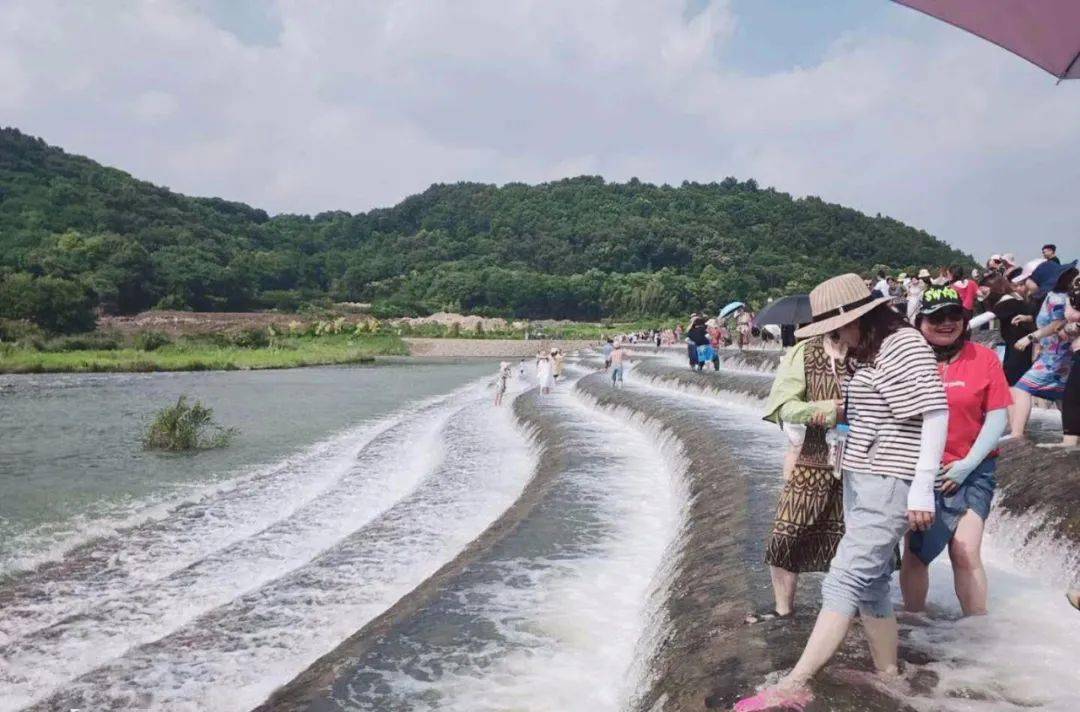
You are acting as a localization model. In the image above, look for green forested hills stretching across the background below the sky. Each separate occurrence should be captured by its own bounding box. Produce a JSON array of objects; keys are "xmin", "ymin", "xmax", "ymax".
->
[{"xmin": 0, "ymin": 129, "xmax": 970, "ymax": 330}]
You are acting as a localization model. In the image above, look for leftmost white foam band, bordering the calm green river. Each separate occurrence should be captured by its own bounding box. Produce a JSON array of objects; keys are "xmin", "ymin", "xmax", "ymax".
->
[{"xmin": 0, "ymin": 386, "xmax": 476, "ymax": 646}]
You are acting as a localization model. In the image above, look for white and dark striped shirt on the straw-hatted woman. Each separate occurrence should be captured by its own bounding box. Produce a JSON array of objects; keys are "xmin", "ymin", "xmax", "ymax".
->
[{"xmin": 843, "ymin": 328, "xmax": 948, "ymax": 480}]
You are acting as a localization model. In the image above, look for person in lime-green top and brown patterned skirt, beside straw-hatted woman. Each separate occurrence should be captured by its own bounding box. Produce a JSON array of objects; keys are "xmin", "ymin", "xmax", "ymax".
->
[{"xmin": 746, "ymin": 317, "xmax": 848, "ymax": 623}]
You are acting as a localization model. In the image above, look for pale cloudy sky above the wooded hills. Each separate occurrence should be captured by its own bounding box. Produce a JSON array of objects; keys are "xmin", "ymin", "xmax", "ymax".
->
[{"xmin": 0, "ymin": 0, "xmax": 1080, "ymax": 259}]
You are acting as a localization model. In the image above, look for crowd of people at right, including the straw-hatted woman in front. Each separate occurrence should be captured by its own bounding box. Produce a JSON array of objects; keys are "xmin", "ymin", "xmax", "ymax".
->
[{"xmin": 735, "ymin": 245, "xmax": 1080, "ymax": 712}]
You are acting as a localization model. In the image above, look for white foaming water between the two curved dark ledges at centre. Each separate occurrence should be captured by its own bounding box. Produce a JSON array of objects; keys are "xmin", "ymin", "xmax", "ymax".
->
[{"xmin": 336, "ymin": 382, "xmax": 685, "ymax": 712}]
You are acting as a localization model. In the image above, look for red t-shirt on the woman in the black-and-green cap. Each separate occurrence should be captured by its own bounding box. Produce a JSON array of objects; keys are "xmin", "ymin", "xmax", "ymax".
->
[{"xmin": 939, "ymin": 341, "xmax": 1012, "ymax": 465}]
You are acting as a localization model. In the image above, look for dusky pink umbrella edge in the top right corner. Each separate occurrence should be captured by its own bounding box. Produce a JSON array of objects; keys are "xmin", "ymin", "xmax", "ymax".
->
[{"xmin": 894, "ymin": 0, "xmax": 1080, "ymax": 81}]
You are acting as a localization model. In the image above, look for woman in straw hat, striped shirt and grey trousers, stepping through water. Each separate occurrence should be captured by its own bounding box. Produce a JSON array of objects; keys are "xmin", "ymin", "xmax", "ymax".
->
[{"xmin": 735, "ymin": 274, "xmax": 948, "ymax": 712}]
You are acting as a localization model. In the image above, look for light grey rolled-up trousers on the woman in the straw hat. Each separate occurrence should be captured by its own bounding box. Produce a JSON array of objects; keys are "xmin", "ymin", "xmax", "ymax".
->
[{"xmin": 821, "ymin": 470, "xmax": 910, "ymax": 618}]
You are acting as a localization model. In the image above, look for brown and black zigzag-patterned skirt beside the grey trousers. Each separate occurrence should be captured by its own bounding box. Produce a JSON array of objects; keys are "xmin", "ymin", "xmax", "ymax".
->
[{"xmin": 765, "ymin": 465, "xmax": 843, "ymax": 573}]
